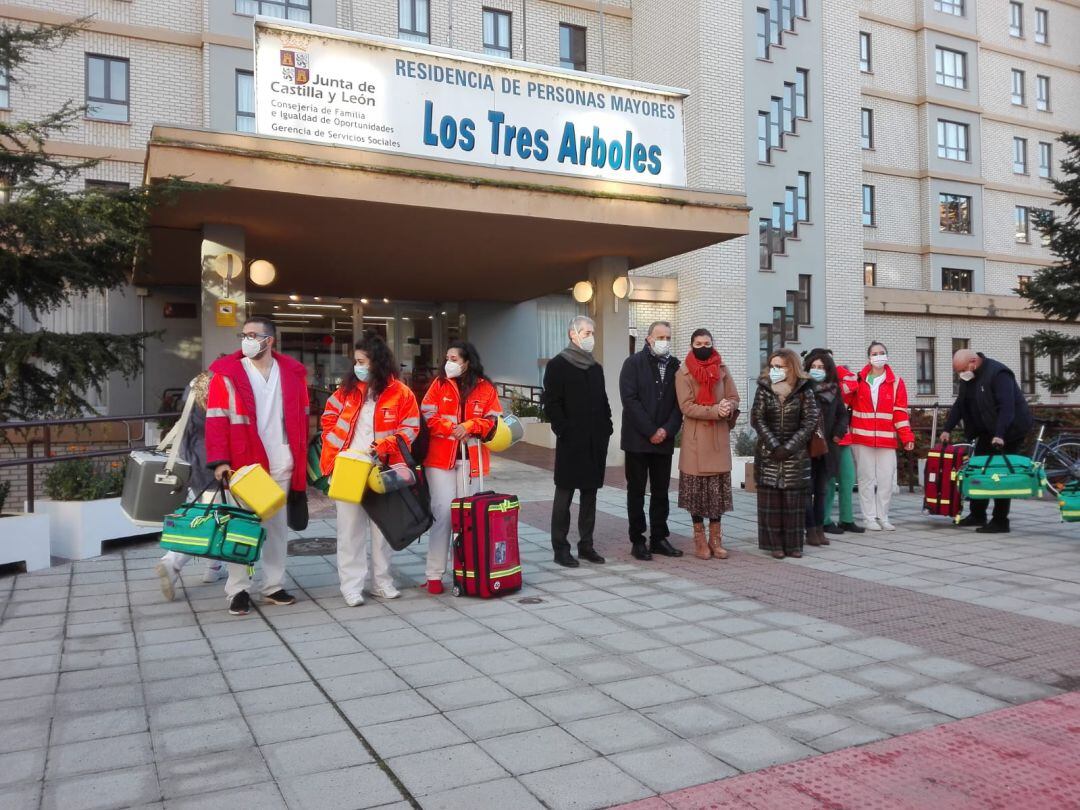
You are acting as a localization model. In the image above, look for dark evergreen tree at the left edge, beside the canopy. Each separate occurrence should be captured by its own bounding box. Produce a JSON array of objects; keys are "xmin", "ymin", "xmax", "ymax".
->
[{"xmin": 0, "ymin": 24, "xmax": 171, "ymax": 421}]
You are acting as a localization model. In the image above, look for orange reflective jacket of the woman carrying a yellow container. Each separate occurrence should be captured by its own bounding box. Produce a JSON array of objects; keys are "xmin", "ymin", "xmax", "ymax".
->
[{"xmin": 319, "ymin": 380, "xmax": 420, "ymax": 475}]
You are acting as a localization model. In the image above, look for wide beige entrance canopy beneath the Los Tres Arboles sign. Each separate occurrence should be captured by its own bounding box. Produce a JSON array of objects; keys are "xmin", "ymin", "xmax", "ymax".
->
[{"xmin": 136, "ymin": 126, "xmax": 750, "ymax": 301}]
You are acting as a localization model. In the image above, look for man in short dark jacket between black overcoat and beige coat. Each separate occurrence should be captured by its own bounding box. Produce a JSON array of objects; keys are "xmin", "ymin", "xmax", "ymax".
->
[{"xmin": 619, "ymin": 321, "xmax": 683, "ymax": 559}]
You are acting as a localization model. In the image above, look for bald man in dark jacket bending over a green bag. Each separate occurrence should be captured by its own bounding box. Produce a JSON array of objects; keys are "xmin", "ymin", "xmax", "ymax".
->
[{"xmin": 941, "ymin": 349, "xmax": 1032, "ymax": 534}]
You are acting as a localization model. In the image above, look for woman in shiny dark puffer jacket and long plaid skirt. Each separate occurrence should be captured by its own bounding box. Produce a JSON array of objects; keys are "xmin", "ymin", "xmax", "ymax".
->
[{"xmin": 750, "ymin": 349, "xmax": 819, "ymax": 559}]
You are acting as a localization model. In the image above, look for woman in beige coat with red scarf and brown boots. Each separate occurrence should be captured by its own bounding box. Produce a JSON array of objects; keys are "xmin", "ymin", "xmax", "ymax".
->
[{"xmin": 675, "ymin": 329, "xmax": 739, "ymax": 559}]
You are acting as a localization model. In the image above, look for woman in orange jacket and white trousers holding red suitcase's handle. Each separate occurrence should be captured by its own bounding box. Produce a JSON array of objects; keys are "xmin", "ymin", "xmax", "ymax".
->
[{"xmin": 420, "ymin": 340, "xmax": 502, "ymax": 594}]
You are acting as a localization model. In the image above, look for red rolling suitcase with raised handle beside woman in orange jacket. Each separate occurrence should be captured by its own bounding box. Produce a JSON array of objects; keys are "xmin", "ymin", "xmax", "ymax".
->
[{"xmin": 450, "ymin": 444, "xmax": 522, "ymax": 599}]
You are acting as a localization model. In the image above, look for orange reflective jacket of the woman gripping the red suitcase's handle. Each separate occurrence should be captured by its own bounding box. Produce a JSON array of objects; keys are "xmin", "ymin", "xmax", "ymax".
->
[{"xmin": 420, "ymin": 377, "xmax": 502, "ymax": 478}]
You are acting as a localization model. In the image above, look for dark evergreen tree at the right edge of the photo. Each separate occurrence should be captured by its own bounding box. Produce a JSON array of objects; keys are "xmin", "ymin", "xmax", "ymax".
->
[{"xmin": 1017, "ymin": 133, "xmax": 1080, "ymax": 392}]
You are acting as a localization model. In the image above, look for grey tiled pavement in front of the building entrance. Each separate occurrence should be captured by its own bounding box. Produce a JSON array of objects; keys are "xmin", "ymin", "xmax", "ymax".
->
[{"xmin": 0, "ymin": 461, "xmax": 1080, "ymax": 810}]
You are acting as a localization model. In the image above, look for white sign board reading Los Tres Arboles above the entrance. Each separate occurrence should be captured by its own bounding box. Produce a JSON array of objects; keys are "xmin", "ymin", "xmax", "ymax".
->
[{"xmin": 255, "ymin": 18, "xmax": 686, "ymax": 186}]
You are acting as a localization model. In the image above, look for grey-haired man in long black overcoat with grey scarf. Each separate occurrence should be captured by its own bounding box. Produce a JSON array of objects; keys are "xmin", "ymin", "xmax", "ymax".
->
[{"xmin": 542, "ymin": 315, "xmax": 615, "ymax": 568}]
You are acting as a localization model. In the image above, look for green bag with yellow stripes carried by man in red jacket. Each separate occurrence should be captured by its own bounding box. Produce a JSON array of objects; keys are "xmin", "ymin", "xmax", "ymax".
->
[{"xmin": 161, "ymin": 487, "xmax": 266, "ymax": 566}]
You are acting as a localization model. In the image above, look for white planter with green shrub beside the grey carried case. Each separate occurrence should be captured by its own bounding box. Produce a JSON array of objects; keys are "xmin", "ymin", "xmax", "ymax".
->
[{"xmin": 37, "ymin": 459, "xmax": 147, "ymax": 559}]
